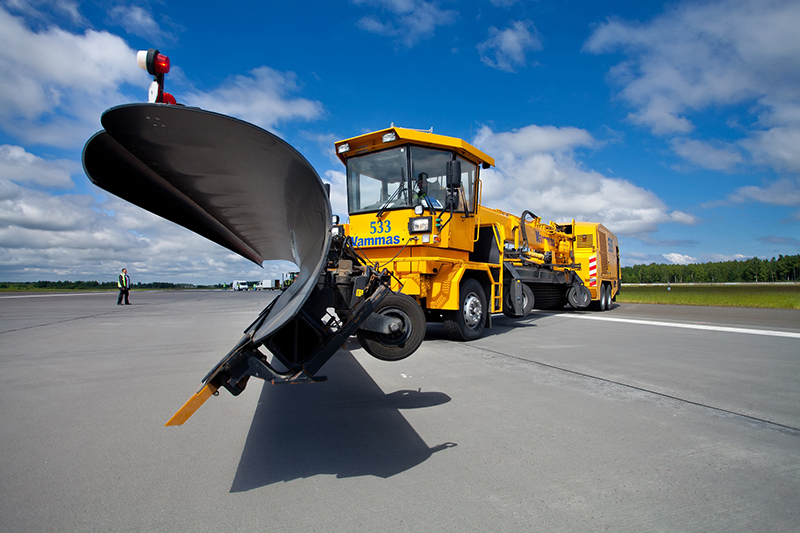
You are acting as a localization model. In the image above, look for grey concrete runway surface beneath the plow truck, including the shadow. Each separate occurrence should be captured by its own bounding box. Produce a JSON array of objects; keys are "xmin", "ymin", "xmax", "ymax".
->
[{"xmin": 0, "ymin": 291, "xmax": 800, "ymax": 532}]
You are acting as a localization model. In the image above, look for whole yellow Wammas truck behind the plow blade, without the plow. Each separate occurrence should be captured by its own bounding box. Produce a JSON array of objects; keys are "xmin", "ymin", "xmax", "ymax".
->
[{"xmin": 333, "ymin": 127, "xmax": 620, "ymax": 348}]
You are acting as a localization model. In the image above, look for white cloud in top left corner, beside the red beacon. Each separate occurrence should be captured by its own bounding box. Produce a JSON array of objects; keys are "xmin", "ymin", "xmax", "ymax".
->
[{"xmin": 0, "ymin": 8, "xmax": 143, "ymax": 147}]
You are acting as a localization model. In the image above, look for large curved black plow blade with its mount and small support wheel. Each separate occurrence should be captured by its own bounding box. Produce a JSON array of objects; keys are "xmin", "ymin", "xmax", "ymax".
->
[{"xmin": 83, "ymin": 104, "xmax": 425, "ymax": 425}]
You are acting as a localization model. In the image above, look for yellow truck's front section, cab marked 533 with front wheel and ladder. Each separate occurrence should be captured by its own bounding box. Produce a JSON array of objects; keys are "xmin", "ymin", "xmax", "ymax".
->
[{"xmin": 336, "ymin": 126, "xmax": 502, "ymax": 340}]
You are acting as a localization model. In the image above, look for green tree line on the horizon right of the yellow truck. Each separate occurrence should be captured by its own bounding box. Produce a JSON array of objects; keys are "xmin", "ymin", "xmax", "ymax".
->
[{"xmin": 622, "ymin": 255, "xmax": 800, "ymax": 283}]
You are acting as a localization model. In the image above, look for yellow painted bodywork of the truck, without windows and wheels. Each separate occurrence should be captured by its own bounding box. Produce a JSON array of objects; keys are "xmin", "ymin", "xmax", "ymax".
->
[{"xmin": 336, "ymin": 127, "xmax": 619, "ymax": 312}]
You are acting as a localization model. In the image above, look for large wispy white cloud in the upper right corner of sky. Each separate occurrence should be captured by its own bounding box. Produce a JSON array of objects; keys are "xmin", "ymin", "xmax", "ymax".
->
[{"xmin": 584, "ymin": 0, "xmax": 800, "ymax": 173}]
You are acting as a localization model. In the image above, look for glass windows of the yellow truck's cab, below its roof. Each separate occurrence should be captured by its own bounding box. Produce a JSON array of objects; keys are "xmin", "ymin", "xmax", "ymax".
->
[{"xmin": 347, "ymin": 146, "xmax": 477, "ymax": 214}]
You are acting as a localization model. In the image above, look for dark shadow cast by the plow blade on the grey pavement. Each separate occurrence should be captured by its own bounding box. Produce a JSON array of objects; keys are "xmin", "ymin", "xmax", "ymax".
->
[{"xmin": 231, "ymin": 350, "xmax": 456, "ymax": 492}]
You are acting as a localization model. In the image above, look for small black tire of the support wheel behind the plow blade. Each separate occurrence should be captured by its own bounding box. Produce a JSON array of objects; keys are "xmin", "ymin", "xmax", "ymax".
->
[{"xmin": 356, "ymin": 293, "xmax": 425, "ymax": 361}]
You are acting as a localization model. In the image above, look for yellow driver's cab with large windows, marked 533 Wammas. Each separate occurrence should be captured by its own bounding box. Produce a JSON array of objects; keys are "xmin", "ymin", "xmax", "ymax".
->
[{"xmin": 336, "ymin": 127, "xmax": 494, "ymax": 251}]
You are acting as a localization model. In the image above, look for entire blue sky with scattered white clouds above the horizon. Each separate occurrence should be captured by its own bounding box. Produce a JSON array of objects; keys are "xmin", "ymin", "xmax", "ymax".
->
[{"xmin": 0, "ymin": 0, "xmax": 800, "ymax": 283}]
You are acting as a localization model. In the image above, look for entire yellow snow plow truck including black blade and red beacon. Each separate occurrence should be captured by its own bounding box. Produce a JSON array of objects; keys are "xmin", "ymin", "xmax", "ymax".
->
[{"xmin": 83, "ymin": 49, "xmax": 619, "ymax": 425}]
